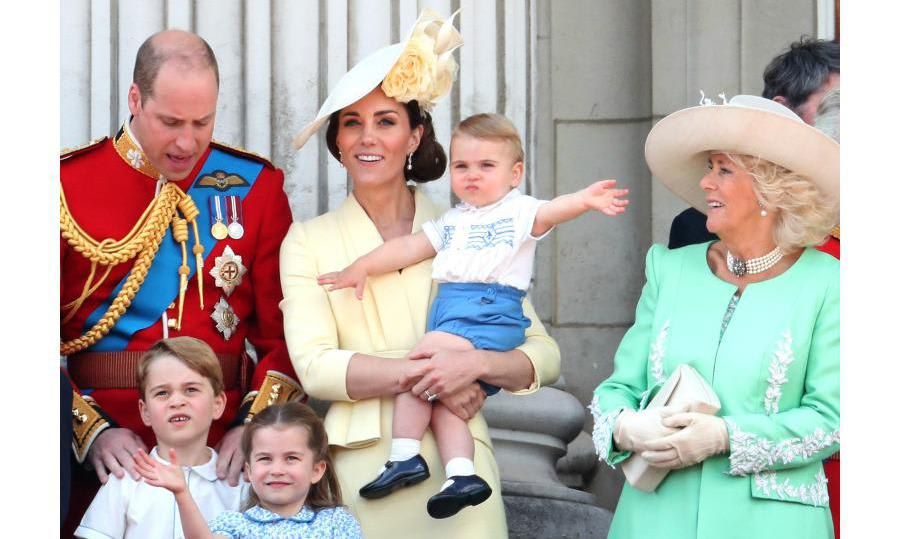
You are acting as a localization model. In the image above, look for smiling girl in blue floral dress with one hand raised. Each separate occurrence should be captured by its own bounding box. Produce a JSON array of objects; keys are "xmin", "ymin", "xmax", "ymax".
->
[{"xmin": 137, "ymin": 402, "xmax": 362, "ymax": 539}]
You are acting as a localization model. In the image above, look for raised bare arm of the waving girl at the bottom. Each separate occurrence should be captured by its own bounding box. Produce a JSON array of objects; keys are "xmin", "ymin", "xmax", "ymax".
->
[{"xmin": 134, "ymin": 449, "xmax": 222, "ymax": 539}]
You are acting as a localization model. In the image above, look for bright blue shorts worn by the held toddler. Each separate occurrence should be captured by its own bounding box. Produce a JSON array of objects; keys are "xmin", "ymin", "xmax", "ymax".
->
[{"xmin": 428, "ymin": 283, "xmax": 531, "ymax": 395}]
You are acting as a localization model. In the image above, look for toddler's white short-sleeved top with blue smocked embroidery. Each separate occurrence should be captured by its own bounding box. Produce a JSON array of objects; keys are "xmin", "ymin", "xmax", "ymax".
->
[{"xmin": 422, "ymin": 188, "xmax": 552, "ymax": 291}]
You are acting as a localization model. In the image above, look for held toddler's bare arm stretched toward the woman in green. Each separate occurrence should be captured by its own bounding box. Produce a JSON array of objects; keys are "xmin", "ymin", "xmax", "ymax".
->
[{"xmin": 531, "ymin": 180, "xmax": 629, "ymax": 237}]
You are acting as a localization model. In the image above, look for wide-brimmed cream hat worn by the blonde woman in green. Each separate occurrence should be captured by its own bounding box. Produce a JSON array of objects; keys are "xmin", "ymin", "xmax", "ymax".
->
[{"xmin": 644, "ymin": 95, "xmax": 840, "ymax": 213}]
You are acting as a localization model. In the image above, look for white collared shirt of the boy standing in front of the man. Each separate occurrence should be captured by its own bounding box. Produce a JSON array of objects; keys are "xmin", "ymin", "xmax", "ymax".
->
[{"xmin": 75, "ymin": 447, "xmax": 249, "ymax": 539}]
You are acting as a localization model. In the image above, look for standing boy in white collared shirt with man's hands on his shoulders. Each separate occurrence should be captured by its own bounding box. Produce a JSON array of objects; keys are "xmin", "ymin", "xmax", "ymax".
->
[{"xmin": 75, "ymin": 337, "xmax": 247, "ymax": 539}]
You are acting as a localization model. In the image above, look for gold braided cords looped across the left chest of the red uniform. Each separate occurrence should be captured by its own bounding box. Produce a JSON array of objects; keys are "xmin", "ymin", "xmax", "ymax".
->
[{"xmin": 59, "ymin": 183, "xmax": 195, "ymax": 355}]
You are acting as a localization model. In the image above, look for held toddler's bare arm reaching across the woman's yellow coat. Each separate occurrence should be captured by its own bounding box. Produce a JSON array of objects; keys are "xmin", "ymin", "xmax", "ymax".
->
[{"xmin": 318, "ymin": 232, "xmax": 437, "ymax": 299}]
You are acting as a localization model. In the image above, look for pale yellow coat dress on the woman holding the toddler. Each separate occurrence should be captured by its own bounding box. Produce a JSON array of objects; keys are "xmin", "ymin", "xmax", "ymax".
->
[{"xmin": 281, "ymin": 190, "xmax": 560, "ymax": 539}]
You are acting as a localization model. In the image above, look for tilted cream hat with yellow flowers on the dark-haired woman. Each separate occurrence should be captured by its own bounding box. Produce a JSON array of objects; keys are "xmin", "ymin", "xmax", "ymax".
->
[{"xmin": 293, "ymin": 9, "xmax": 462, "ymax": 149}]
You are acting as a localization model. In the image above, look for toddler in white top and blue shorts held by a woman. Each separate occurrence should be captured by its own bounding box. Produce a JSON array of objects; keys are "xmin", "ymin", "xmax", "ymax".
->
[{"xmin": 318, "ymin": 114, "xmax": 628, "ymax": 518}]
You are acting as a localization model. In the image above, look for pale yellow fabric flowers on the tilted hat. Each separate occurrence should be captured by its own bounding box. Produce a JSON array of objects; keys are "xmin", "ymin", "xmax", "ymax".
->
[{"xmin": 381, "ymin": 10, "xmax": 462, "ymax": 110}]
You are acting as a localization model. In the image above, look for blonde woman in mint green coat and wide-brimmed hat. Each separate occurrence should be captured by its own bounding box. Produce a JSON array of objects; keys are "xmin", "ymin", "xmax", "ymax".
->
[{"xmin": 590, "ymin": 96, "xmax": 840, "ymax": 539}]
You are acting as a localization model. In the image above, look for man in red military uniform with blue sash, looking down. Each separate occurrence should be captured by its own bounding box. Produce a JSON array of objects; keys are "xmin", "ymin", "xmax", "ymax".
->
[{"xmin": 60, "ymin": 31, "xmax": 305, "ymax": 529}]
